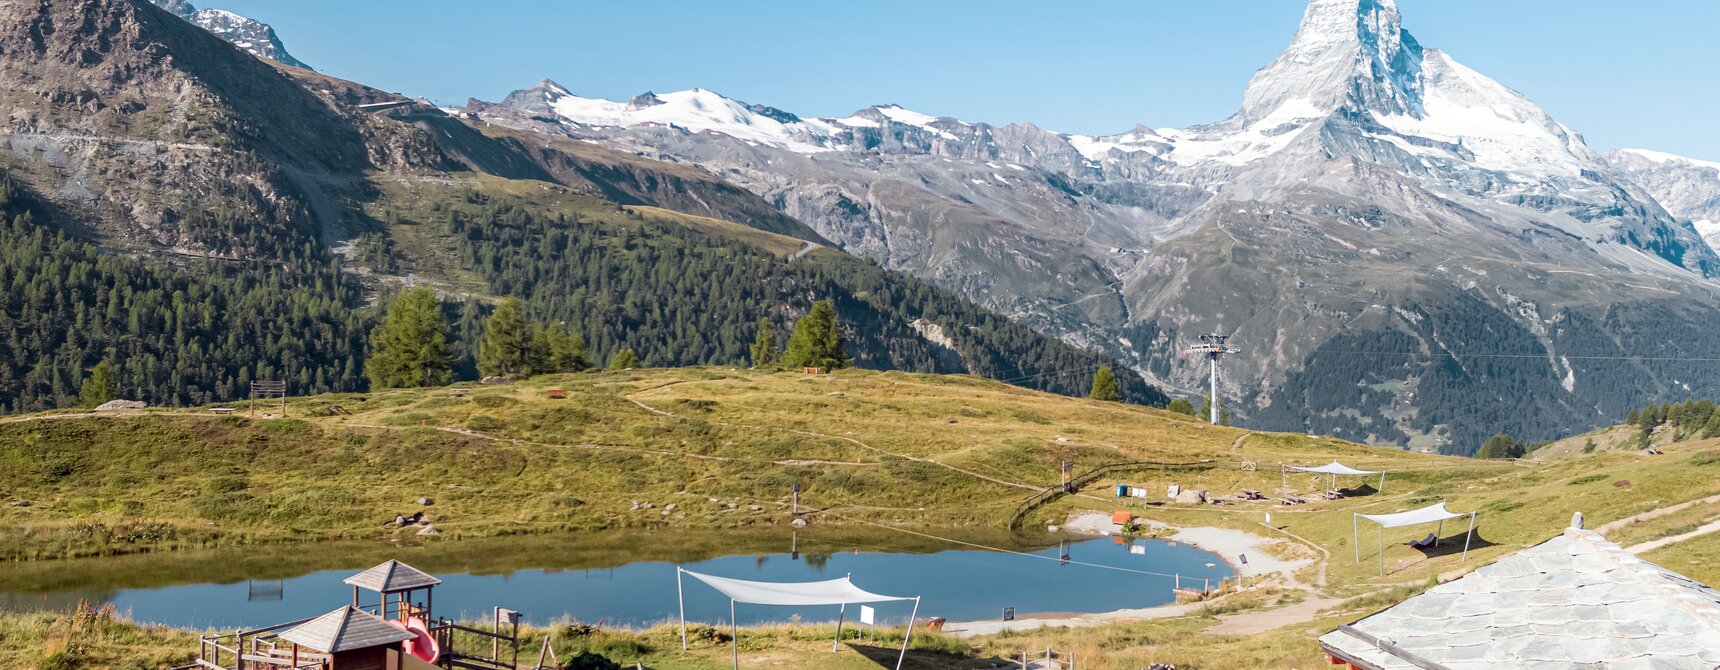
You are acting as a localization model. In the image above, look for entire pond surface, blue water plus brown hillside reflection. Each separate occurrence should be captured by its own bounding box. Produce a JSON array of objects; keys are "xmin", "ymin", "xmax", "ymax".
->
[{"xmin": 0, "ymin": 531, "xmax": 1232, "ymax": 629}]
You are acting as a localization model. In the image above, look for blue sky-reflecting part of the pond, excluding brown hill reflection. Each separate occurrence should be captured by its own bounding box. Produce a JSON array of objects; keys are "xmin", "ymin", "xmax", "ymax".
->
[{"xmin": 0, "ymin": 538, "xmax": 1232, "ymax": 629}]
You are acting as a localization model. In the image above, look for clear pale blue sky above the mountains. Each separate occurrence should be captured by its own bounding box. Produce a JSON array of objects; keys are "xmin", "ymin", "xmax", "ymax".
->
[{"xmin": 211, "ymin": 0, "xmax": 1720, "ymax": 160}]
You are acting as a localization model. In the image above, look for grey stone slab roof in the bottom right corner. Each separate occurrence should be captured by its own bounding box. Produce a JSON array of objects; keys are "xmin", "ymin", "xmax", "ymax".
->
[{"xmin": 1319, "ymin": 527, "xmax": 1720, "ymax": 670}]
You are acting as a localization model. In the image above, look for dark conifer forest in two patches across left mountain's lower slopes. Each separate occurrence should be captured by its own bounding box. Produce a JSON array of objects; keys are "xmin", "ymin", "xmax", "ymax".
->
[{"xmin": 0, "ymin": 175, "xmax": 1163, "ymax": 412}]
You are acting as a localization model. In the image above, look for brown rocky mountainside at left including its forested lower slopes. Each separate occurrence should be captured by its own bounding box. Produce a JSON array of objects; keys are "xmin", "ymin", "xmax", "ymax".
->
[{"xmin": 0, "ymin": 0, "xmax": 1164, "ymax": 411}]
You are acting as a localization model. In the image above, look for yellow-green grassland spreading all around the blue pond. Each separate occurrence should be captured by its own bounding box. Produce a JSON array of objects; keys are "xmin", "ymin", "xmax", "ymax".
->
[{"xmin": 0, "ymin": 368, "xmax": 1720, "ymax": 668}]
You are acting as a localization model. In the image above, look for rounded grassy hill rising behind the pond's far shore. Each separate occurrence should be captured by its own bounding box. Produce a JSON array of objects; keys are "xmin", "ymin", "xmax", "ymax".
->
[{"xmin": 0, "ymin": 368, "xmax": 1410, "ymax": 558}]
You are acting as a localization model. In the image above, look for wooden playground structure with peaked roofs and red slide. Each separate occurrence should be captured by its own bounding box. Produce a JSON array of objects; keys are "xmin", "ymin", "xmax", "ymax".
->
[{"xmin": 175, "ymin": 560, "xmax": 546, "ymax": 670}]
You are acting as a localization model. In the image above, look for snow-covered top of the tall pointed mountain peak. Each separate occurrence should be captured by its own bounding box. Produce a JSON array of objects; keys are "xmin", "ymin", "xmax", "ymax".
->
[{"xmin": 1166, "ymin": 0, "xmax": 1598, "ymax": 180}]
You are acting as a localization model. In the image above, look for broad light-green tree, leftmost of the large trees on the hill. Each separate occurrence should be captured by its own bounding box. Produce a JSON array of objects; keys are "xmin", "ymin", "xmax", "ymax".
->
[{"xmin": 365, "ymin": 287, "xmax": 454, "ymax": 388}]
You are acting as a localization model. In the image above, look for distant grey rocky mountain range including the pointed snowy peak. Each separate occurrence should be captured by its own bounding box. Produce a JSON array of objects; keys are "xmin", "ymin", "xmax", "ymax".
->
[{"xmin": 471, "ymin": 0, "xmax": 1720, "ymax": 452}]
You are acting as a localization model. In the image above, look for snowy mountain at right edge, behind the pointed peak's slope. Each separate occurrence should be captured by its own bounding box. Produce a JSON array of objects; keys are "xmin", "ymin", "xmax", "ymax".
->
[{"xmin": 1601, "ymin": 149, "xmax": 1720, "ymax": 249}]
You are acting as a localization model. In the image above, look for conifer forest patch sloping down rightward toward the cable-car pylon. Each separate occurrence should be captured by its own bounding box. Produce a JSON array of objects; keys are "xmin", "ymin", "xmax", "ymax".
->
[{"xmin": 436, "ymin": 191, "xmax": 1168, "ymax": 405}]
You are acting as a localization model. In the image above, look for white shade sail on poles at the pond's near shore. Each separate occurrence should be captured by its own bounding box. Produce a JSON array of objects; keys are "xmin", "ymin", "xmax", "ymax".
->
[{"xmin": 674, "ymin": 565, "xmax": 920, "ymax": 670}]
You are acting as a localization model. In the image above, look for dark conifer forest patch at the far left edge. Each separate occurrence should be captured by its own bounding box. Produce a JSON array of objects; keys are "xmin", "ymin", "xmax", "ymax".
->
[{"xmin": 0, "ymin": 177, "xmax": 372, "ymax": 412}]
